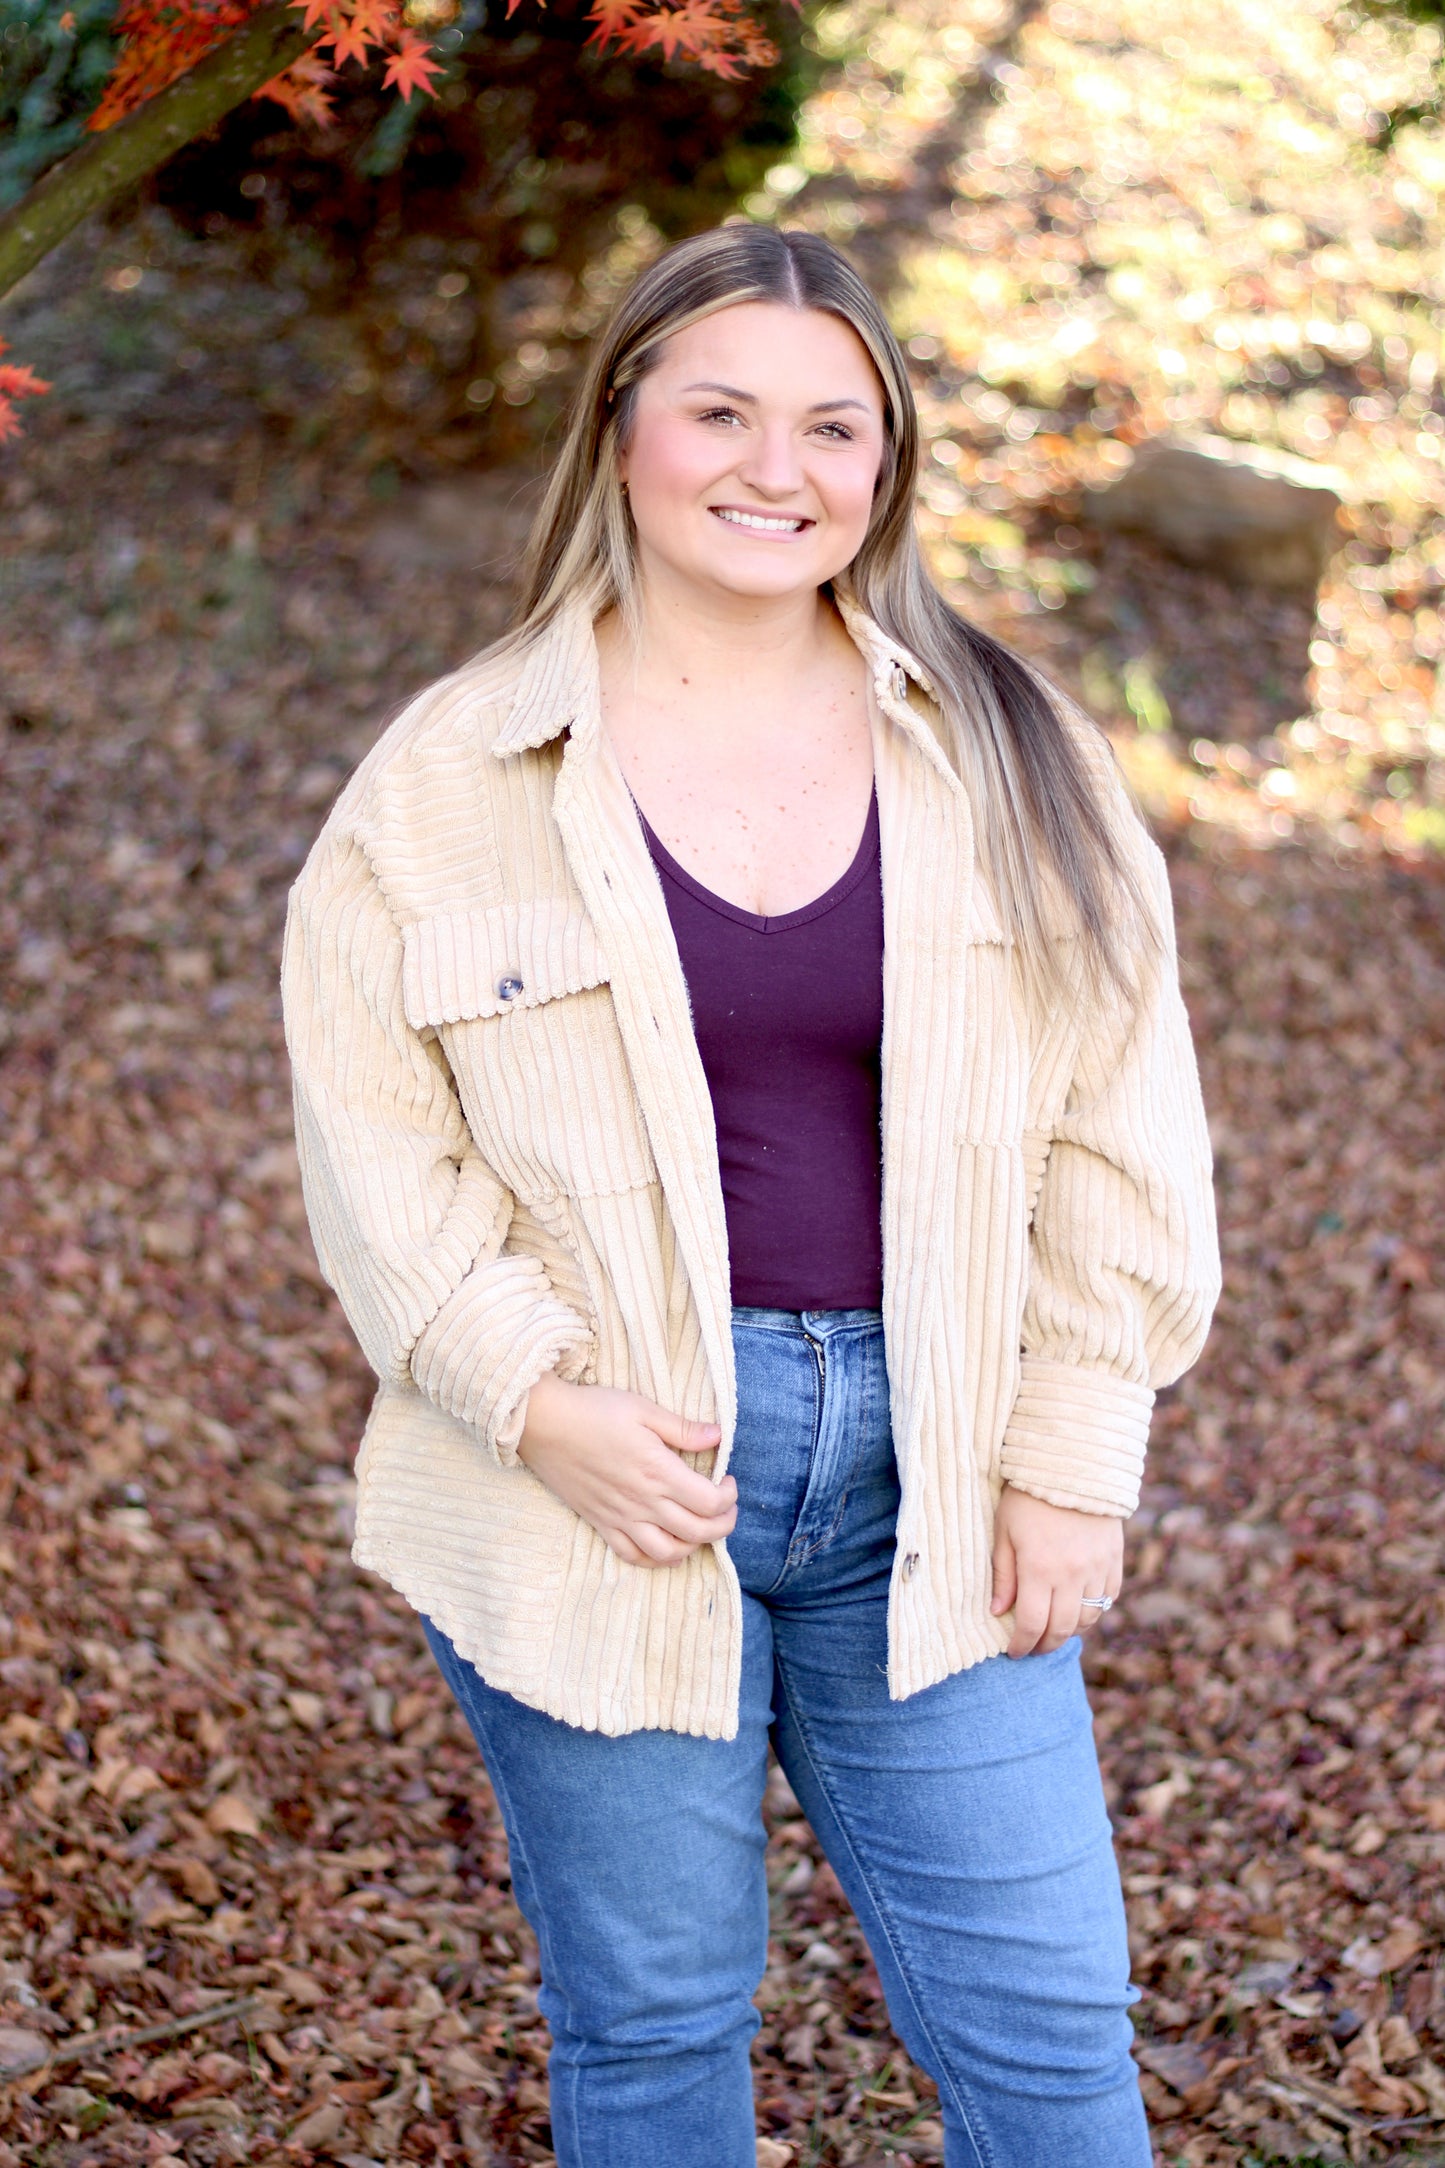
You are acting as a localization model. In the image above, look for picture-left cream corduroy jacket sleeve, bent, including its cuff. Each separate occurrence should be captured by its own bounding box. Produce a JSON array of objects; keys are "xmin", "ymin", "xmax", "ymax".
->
[{"xmin": 282, "ymin": 833, "xmax": 594, "ymax": 1466}]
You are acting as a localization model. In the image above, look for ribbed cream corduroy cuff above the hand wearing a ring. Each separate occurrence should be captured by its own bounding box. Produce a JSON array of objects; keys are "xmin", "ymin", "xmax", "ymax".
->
[{"xmin": 1001, "ymin": 1355, "xmax": 1155, "ymax": 1520}]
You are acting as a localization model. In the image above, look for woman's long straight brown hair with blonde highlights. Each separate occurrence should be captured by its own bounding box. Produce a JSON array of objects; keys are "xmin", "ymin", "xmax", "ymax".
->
[{"xmin": 509, "ymin": 221, "xmax": 1153, "ymax": 993}]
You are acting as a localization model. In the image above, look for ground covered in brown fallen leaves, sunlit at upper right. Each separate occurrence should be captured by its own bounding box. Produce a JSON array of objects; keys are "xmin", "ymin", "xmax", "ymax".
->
[{"xmin": 0, "ymin": 0, "xmax": 1445, "ymax": 2168}]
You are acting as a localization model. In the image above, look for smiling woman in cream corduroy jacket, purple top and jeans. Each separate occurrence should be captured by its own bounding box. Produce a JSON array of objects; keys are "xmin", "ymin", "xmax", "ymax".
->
[{"xmin": 284, "ymin": 223, "xmax": 1215, "ymax": 2168}]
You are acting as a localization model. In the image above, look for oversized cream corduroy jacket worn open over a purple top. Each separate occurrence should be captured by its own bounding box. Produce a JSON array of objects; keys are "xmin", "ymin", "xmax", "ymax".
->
[{"xmin": 282, "ymin": 607, "xmax": 1218, "ymax": 1739}]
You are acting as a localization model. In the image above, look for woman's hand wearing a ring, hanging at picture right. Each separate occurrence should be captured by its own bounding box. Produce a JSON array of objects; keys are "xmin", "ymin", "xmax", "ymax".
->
[{"xmin": 990, "ymin": 1483, "xmax": 1124, "ymax": 1656}]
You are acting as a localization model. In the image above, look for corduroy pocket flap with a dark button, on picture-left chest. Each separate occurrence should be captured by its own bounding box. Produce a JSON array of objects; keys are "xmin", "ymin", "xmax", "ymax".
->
[{"xmin": 401, "ymin": 895, "xmax": 607, "ymax": 1030}]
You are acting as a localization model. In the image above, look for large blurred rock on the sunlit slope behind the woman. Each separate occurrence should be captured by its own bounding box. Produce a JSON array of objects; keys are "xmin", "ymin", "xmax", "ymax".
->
[{"xmin": 1085, "ymin": 436, "xmax": 1345, "ymax": 590}]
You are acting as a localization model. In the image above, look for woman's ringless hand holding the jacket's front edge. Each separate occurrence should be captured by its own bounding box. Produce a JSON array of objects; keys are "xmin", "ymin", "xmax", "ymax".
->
[{"xmin": 518, "ymin": 1370, "xmax": 737, "ymax": 1565}]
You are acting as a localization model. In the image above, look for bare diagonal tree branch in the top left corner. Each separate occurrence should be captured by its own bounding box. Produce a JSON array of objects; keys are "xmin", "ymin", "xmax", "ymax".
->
[{"xmin": 0, "ymin": 0, "xmax": 321, "ymax": 295}]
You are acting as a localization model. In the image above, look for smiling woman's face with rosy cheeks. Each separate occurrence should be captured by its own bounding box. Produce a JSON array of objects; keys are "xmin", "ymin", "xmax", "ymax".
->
[{"xmin": 622, "ymin": 301, "xmax": 884, "ymax": 601}]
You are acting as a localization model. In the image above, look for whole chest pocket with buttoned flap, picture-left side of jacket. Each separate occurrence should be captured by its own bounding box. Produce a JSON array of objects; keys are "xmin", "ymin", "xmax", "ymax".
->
[{"xmin": 403, "ymin": 895, "xmax": 656, "ymax": 1201}]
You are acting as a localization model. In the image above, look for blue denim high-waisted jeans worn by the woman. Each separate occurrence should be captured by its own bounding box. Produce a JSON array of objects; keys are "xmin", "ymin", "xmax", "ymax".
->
[{"xmin": 422, "ymin": 1309, "xmax": 1150, "ymax": 2168}]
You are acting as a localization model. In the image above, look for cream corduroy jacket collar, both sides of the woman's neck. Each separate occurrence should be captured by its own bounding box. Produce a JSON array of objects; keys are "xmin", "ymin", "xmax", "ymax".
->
[{"xmin": 492, "ymin": 594, "xmax": 958, "ymax": 783}]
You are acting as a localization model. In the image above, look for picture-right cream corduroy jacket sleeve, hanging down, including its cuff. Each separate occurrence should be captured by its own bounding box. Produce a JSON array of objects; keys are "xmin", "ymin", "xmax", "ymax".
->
[{"xmin": 1001, "ymin": 843, "xmax": 1220, "ymax": 1518}]
